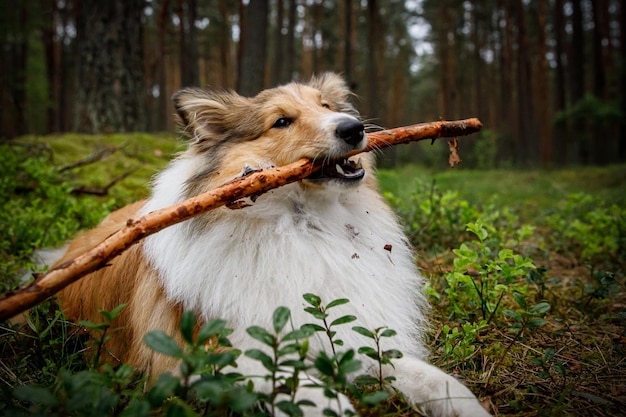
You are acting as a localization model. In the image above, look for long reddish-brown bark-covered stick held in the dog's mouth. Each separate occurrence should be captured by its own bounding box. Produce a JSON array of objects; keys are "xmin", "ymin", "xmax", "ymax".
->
[{"xmin": 0, "ymin": 119, "xmax": 482, "ymax": 321}]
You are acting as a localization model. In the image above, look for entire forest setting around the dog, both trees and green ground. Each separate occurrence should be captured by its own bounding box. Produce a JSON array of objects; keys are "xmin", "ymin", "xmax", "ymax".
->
[{"xmin": 0, "ymin": 0, "xmax": 626, "ymax": 417}]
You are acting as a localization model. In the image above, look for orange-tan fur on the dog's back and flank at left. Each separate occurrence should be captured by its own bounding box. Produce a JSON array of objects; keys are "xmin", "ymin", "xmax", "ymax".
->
[{"xmin": 55, "ymin": 201, "xmax": 182, "ymax": 375}]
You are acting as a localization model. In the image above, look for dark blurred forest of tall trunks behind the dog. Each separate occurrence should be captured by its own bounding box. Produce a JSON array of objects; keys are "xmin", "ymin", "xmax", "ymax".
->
[{"xmin": 0, "ymin": 0, "xmax": 626, "ymax": 168}]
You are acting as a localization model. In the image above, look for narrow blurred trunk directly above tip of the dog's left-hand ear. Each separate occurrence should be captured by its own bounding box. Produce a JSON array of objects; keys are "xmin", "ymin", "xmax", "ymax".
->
[{"xmin": 177, "ymin": 0, "xmax": 200, "ymax": 87}]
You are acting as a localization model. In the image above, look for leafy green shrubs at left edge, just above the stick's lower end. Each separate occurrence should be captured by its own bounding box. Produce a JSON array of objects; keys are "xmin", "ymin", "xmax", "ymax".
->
[{"xmin": 0, "ymin": 145, "xmax": 110, "ymax": 290}]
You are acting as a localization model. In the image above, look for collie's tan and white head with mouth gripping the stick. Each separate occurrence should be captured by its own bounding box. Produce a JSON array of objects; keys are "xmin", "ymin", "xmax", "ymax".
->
[{"xmin": 174, "ymin": 73, "xmax": 369, "ymax": 192}]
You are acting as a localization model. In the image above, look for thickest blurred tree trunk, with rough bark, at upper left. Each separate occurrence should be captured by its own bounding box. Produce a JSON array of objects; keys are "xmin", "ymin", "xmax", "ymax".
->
[{"xmin": 74, "ymin": 0, "xmax": 145, "ymax": 132}]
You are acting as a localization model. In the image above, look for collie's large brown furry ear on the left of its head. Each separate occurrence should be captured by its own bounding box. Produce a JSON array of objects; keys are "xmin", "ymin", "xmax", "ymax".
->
[{"xmin": 172, "ymin": 88, "xmax": 262, "ymax": 144}]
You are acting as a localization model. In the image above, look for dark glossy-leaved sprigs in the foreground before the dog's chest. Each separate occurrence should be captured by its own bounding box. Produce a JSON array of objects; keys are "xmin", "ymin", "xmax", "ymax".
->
[{"xmin": 0, "ymin": 294, "xmax": 401, "ymax": 416}]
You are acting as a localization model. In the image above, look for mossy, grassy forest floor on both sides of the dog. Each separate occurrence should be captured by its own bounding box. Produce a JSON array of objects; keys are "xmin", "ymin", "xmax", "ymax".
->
[{"xmin": 0, "ymin": 134, "xmax": 626, "ymax": 416}]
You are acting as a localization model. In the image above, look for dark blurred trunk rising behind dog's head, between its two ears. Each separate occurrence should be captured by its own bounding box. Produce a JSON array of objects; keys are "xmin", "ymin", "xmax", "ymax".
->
[{"xmin": 238, "ymin": 0, "xmax": 269, "ymax": 96}]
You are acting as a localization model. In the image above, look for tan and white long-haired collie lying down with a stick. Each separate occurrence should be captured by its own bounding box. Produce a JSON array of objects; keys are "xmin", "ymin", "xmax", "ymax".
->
[{"xmin": 51, "ymin": 73, "xmax": 488, "ymax": 417}]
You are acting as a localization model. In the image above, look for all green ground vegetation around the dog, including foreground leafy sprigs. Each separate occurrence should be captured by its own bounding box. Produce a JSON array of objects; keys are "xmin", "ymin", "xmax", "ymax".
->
[{"xmin": 0, "ymin": 135, "xmax": 626, "ymax": 416}]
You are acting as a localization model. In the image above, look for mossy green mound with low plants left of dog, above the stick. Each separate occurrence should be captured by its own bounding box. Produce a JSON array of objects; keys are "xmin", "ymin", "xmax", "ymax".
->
[{"xmin": 0, "ymin": 134, "xmax": 178, "ymax": 292}]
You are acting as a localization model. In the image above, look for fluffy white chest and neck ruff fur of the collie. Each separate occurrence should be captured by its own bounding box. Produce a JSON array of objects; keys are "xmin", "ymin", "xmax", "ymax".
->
[{"xmin": 144, "ymin": 164, "xmax": 425, "ymax": 356}]
